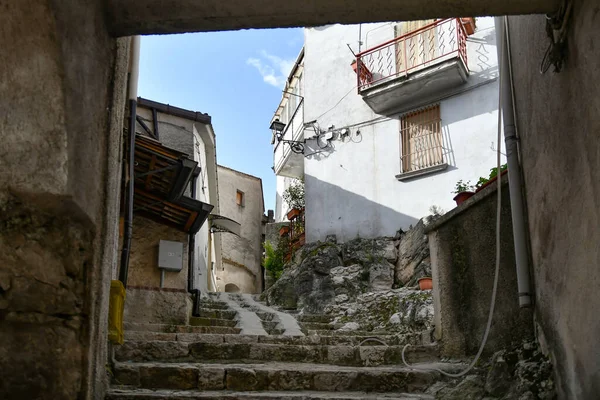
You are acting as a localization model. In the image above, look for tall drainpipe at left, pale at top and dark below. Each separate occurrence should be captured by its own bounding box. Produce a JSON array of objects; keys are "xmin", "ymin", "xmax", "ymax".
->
[{"xmin": 119, "ymin": 36, "xmax": 140, "ymax": 287}]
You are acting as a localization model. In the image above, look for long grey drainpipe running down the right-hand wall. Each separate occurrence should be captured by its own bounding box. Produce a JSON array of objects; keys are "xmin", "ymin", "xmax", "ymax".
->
[{"xmin": 495, "ymin": 17, "xmax": 532, "ymax": 308}]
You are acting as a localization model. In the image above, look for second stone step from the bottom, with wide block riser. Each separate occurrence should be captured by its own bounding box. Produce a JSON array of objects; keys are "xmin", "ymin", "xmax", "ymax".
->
[{"xmin": 114, "ymin": 362, "xmax": 454, "ymax": 393}]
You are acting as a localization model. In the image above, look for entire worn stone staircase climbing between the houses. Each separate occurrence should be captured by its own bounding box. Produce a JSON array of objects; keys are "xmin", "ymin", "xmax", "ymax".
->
[{"xmin": 107, "ymin": 294, "xmax": 461, "ymax": 400}]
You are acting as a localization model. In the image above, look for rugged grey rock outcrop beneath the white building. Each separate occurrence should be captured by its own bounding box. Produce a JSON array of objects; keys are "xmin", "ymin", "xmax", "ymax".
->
[{"xmin": 263, "ymin": 220, "xmax": 431, "ymax": 314}]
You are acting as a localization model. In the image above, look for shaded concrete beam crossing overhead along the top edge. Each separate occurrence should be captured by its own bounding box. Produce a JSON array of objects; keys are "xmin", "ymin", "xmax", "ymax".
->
[{"xmin": 108, "ymin": 0, "xmax": 559, "ymax": 35}]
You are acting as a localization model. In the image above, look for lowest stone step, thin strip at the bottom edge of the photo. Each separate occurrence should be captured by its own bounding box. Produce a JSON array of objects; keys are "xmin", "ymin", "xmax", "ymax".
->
[{"xmin": 106, "ymin": 389, "xmax": 434, "ymax": 400}]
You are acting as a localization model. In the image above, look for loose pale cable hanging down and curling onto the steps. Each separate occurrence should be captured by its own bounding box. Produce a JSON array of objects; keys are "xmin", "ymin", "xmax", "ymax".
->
[{"xmin": 402, "ymin": 15, "xmax": 508, "ymax": 378}]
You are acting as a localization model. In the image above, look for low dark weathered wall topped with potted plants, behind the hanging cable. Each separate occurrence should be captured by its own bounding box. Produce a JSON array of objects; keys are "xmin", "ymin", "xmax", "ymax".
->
[{"xmin": 426, "ymin": 176, "xmax": 533, "ymax": 357}]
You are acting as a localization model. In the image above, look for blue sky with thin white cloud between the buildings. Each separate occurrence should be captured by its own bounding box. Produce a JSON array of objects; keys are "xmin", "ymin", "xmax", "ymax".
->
[{"xmin": 139, "ymin": 29, "xmax": 304, "ymax": 209}]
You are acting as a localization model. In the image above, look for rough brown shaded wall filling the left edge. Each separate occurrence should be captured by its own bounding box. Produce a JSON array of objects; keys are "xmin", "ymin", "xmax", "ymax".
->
[{"xmin": 0, "ymin": 0, "xmax": 128, "ymax": 399}]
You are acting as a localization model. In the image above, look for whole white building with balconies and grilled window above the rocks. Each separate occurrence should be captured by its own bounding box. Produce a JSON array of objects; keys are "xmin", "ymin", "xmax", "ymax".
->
[{"xmin": 273, "ymin": 17, "xmax": 498, "ymax": 242}]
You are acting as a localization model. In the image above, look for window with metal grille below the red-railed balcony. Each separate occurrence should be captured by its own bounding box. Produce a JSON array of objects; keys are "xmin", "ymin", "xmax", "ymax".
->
[{"xmin": 400, "ymin": 104, "xmax": 444, "ymax": 173}]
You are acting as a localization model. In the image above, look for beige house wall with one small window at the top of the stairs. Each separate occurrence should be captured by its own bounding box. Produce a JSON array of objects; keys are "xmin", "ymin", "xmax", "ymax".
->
[{"xmin": 216, "ymin": 166, "xmax": 264, "ymax": 293}]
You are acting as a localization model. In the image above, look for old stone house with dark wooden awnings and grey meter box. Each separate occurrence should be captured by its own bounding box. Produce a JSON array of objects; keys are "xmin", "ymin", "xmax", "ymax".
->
[{"xmin": 118, "ymin": 98, "xmax": 221, "ymax": 323}]
